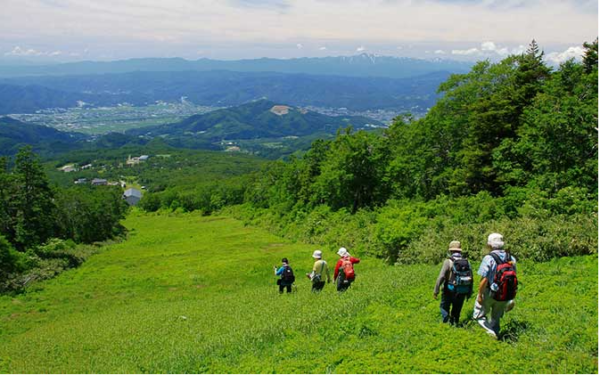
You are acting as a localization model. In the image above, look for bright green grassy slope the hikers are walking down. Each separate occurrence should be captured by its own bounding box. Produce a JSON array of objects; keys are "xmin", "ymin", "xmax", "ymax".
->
[{"xmin": 0, "ymin": 212, "xmax": 598, "ymax": 373}]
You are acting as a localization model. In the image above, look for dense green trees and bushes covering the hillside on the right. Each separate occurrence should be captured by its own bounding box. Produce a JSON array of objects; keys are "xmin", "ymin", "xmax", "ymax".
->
[{"xmin": 143, "ymin": 41, "xmax": 598, "ymax": 262}]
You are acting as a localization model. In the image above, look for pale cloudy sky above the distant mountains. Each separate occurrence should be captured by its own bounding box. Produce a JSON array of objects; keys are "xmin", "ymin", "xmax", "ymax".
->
[{"xmin": 0, "ymin": 0, "xmax": 598, "ymax": 63}]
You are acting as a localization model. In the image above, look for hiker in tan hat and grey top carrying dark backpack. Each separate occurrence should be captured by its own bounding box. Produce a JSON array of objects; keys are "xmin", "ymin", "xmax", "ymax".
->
[{"xmin": 433, "ymin": 241, "xmax": 473, "ymax": 325}]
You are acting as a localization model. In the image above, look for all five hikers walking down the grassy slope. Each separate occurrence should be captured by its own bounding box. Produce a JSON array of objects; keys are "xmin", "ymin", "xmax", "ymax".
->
[{"xmin": 274, "ymin": 233, "xmax": 518, "ymax": 337}]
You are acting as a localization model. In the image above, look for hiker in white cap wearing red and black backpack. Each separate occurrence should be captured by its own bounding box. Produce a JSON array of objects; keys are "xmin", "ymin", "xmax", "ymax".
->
[{"xmin": 473, "ymin": 233, "xmax": 518, "ymax": 338}]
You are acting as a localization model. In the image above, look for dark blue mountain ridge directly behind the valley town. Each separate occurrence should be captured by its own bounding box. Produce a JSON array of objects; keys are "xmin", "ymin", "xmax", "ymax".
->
[{"xmin": 0, "ymin": 71, "xmax": 450, "ymax": 114}]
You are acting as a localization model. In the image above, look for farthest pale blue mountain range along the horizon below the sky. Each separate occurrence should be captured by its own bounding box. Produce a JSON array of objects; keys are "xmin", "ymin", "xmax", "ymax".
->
[{"xmin": 0, "ymin": 53, "xmax": 472, "ymax": 78}]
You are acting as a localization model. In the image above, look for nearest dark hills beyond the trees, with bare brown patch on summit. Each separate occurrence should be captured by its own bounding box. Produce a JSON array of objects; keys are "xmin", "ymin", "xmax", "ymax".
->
[{"xmin": 0, "ymin": 100, "xmax": 382, "ymax": 156}]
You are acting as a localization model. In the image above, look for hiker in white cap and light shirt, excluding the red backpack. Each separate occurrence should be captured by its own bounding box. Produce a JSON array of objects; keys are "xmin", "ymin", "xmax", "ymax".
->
[{"xmin": 473, "ymin": 233, "xmax": 517, "ymax": 337}]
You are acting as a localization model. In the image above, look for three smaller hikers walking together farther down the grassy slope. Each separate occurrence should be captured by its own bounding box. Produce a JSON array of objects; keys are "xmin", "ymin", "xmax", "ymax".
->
[{"xmin": 273, "ymin": 247, "xmax": 360, "ymax": 293}]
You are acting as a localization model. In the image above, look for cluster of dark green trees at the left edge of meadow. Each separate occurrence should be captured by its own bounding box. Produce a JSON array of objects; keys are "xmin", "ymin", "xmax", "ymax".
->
[{"xmin": 0, "ymin": 147, "xmax": 127, "ymax": 290}]
